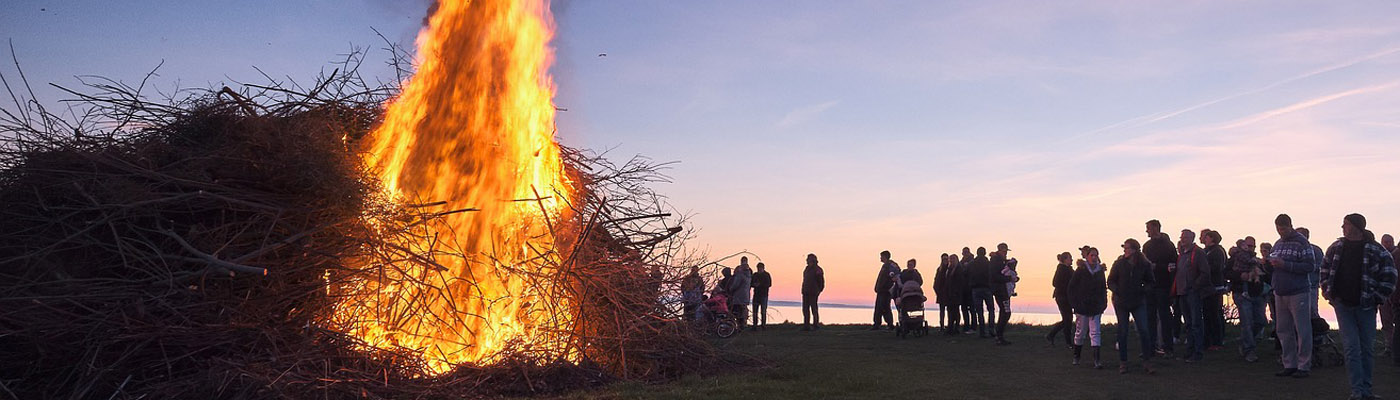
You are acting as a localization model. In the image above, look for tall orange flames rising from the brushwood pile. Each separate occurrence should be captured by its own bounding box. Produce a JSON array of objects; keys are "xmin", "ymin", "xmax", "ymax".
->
[{"xmin": 335, "ymin": 0, "xmax": 573, "ymax": 373}]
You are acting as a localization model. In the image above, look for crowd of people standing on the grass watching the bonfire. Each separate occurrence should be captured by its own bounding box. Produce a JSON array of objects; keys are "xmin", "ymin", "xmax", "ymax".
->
[{"xmin": 682, "ymin": 214, "xmax": 1400, "ymax": 399}]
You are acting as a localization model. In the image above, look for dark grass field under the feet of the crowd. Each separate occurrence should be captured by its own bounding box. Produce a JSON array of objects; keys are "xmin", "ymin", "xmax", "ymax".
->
[{"xmin": 543, "ymin": 324, "xmax": 1400, "ymax": 400}]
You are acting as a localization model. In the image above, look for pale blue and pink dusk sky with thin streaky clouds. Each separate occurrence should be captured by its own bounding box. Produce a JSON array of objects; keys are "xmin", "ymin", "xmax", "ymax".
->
[{"xmin": 0, "ymin": 0, "xmax": 1400, "ymax": 316}]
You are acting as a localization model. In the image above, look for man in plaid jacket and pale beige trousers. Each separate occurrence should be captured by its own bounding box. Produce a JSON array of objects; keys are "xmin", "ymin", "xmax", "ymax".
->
[{"xmin": 1268, "ymin": 214, "xmax": 1317, "ymax": 378}]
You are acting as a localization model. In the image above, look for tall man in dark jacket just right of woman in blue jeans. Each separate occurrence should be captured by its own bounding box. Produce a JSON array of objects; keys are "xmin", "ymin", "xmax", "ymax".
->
[{"xmin": 1142, "ymin": 220, "xmax": 1177, "ymax": 358}]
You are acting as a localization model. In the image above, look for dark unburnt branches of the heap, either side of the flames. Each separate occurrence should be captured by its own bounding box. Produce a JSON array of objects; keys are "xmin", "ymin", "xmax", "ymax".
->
[{"xmin": 0, "ymin": 56, "xmax": 739, "ymax": 399}]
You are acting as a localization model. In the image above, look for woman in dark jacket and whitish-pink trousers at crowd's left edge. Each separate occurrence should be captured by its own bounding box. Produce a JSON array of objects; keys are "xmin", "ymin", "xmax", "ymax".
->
[{"xmin": 1070, "ymin": 246, "xmax": 1109, "ymax": 369}]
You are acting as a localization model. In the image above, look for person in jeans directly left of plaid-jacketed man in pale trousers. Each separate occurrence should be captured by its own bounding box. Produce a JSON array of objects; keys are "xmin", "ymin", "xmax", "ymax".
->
[{"xmin": 1226, "ymin": 236, "xmax": 1267, "ymax": 362}]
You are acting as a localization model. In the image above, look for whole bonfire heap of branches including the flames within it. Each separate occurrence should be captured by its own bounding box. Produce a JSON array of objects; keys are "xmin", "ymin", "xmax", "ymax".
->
[{"xmin": 0, "ymin": 1, "xmax": 739, "ymax": 399}]
